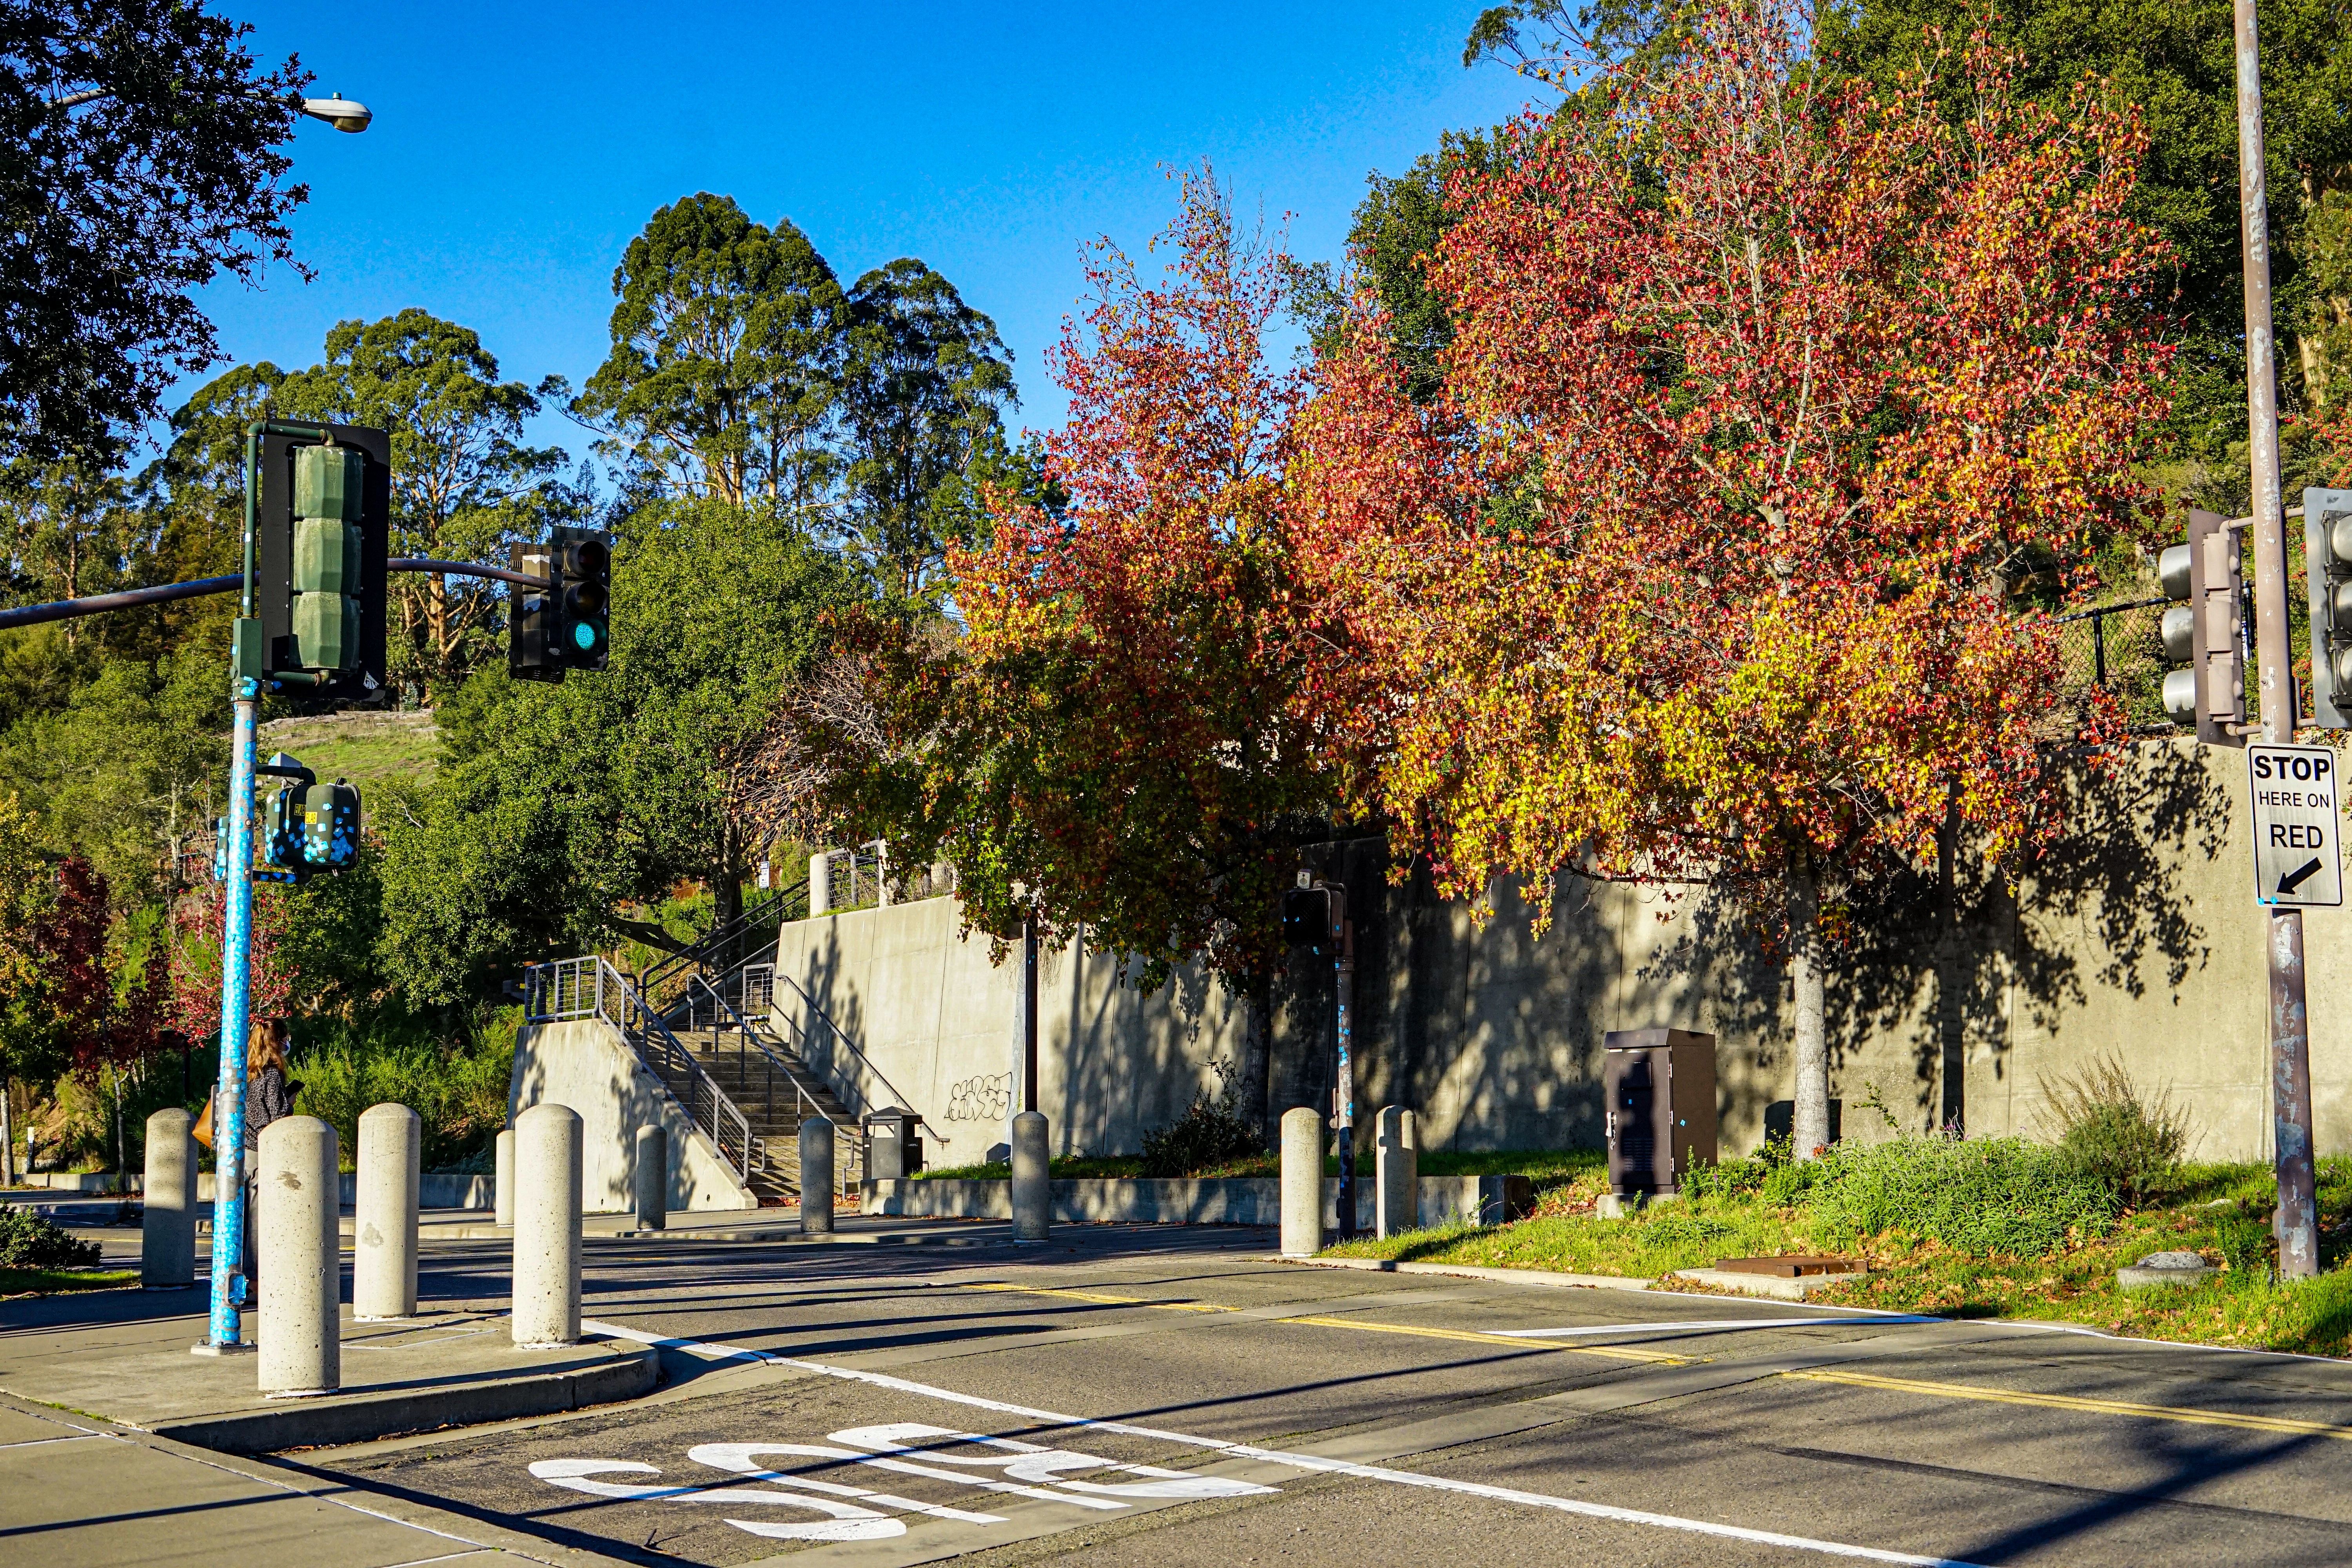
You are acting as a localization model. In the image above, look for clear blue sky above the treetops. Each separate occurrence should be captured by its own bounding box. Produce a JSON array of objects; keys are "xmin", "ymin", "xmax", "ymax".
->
[{"xmin": 181, "ymin": 0, "xmax": 1526, "ymax": 456}]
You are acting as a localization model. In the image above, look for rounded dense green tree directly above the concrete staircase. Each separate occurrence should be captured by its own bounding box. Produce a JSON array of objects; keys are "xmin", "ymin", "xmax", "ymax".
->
[{"xmin": 376, "ymin": 501, "xmax": 863, "ymax": 1006}]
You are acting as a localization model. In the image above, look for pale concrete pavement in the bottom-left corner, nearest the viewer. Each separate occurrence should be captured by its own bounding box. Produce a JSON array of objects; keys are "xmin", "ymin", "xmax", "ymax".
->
[{"xmin": 0, "ymin": 1396, "xmax": 616, "ymax": 1568}]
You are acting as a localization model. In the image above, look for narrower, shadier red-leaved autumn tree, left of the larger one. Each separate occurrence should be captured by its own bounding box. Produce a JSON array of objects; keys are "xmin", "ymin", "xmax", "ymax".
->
[{"xmin": 851, "ymin": 169, "xmax": 1334, "ymax": 1136}]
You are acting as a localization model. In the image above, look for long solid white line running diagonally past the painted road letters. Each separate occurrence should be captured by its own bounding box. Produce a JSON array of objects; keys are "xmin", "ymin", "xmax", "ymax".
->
[{"xmin": 581, "ymin": 1321, "xmax": 1983, "ymax": 1568}]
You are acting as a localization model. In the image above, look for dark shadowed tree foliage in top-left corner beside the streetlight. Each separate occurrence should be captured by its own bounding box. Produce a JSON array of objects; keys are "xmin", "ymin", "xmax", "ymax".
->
[{"xmin": 0, "ymin": 0, "xmax": 310, "ymax": 461}]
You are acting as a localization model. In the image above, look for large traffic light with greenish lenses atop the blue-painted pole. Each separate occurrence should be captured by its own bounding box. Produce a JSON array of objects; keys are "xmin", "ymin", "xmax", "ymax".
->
[{"xmin": 254, "ymin": 423, "xmax": 393, "ymax": 701}]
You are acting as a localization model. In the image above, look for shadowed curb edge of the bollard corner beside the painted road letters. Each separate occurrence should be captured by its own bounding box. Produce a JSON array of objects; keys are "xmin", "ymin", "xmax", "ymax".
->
[{"xmin": 146, "ymin": 1345, "xmax": 661, "ymax": 1455}]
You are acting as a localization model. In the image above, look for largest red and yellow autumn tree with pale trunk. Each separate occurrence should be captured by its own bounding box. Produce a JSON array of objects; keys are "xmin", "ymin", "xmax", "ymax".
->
[{"xmin": 1291, "ymin": 0, "xmax": 2171, "ymax": 1157}]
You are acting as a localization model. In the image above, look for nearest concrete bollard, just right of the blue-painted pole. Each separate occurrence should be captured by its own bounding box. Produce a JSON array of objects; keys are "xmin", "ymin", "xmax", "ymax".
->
[{"xmin": 256, "ymin": 1117, "xmax": 343, "ymax": 1394}]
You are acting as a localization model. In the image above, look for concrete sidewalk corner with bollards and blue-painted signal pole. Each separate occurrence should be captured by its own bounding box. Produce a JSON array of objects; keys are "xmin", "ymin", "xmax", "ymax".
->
[{"xmin": 0, "ymin": 1290, "xmax": 661, "ymax": 1453}]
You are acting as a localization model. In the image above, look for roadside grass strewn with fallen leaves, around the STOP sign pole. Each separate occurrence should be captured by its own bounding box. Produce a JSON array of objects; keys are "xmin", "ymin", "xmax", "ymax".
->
[{"xmin": 1329, "ymin": 1157, "xmax": 2352, "ymax": 1356}]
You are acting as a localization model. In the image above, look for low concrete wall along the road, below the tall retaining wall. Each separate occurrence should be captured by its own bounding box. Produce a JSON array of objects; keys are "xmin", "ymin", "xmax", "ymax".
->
[{"xmin": 863, "ymin": 1171, "xmax": 1529, "ymax": 1232}]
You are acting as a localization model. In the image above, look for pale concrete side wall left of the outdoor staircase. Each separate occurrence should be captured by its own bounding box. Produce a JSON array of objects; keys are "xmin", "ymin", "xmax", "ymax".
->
[{"xmin": 506, "ymin": 1018, "xmax": 760, "ymax": 1213}]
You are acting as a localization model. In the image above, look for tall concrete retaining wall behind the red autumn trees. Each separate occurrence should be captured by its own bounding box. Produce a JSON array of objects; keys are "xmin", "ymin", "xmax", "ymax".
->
[{"xmin": 776, "ymin": 740, "xmax": 2352, "ymax": 1166}]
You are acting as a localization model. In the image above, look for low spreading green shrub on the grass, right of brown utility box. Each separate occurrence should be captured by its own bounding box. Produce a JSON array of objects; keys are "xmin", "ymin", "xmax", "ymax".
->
[{"xmin": 1806, "ymin": 1136, "xmax": 2117, "ymax": 1258}]
